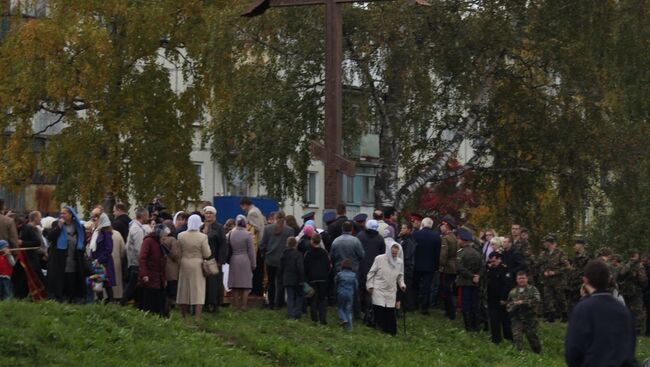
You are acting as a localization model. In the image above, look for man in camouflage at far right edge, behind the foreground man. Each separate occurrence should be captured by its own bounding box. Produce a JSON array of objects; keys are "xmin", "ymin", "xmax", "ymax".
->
[{"xmin": 618, "ymin": 250, "xmax": 648, "ymax": 334}]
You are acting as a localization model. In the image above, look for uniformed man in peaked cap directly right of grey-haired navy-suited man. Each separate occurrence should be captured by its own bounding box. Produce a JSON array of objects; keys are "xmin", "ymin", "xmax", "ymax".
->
[{"xmin": 439, "ymin": 215, "xmax": 458, "ymax": 320}]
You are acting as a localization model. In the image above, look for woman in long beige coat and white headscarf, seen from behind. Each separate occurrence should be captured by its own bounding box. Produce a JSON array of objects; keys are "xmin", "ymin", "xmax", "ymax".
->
[{"xmin": 176, "ymin": 214, "xmax": 210, "ymax": 320}]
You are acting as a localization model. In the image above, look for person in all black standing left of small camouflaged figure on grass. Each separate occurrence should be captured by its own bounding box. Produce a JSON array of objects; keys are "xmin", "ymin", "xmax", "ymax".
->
[{"xmin": 485, "ymin": 252, "xmax": 512, "ymax": 344}]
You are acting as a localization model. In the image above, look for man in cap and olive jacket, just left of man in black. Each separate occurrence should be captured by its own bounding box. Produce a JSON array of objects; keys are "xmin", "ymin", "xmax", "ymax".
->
[{"xmin": 456, "ymin": 228, "xmax": 483, "ymax": 332}]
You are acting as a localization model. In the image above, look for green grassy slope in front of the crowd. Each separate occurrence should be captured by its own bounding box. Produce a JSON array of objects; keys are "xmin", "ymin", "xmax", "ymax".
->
[{"xmin": 0, "ymin": 301, "xmax": 650, "ymax": 366}]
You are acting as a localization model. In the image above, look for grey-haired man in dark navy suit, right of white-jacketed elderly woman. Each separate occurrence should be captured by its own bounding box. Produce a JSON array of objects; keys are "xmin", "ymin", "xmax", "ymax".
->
[{"xmin": 413, "ymin": 218, "xmax": 441, "ymax": 315}]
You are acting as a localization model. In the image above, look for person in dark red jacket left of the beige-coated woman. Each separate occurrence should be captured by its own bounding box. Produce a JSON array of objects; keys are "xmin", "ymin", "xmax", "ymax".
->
[{"xmin": 138, "ymin": 224, "xmax": 169, "ymax": 316}]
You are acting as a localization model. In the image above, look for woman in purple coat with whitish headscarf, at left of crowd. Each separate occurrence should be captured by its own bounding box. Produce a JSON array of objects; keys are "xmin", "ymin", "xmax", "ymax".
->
[{"xmin": 89, "ymin": 213, "xmax": 116, "ymax": 302}]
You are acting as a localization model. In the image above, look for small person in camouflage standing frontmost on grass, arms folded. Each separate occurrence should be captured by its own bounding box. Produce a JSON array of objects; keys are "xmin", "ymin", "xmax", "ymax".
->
[{"xmin": 506, "ymin": 271, "xmax": 542, "ymax": 353}]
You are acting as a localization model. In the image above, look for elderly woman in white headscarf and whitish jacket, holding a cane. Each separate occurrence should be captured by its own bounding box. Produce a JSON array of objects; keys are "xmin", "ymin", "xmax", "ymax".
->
[{"xmin": 366, "ymin": 242, "xmax": 406, "ymax": 335}]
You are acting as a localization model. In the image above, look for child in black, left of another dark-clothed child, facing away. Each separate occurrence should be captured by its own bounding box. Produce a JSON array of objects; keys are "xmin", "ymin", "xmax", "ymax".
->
[{"xmin": 278, "ymin": 237, "xmax": 305, "ymax": 320}]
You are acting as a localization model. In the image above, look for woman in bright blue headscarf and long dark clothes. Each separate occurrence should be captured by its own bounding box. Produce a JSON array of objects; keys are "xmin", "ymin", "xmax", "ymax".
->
[{"xmin": 47, "ymin": 206, "xmax": 87, "ymax": 302}]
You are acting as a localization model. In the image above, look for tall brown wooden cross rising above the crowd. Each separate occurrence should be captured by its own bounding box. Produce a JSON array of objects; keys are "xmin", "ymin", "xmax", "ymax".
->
[{"xmin": 242, "ymin": 0, "xmax": 429, "ymax": 208}]
